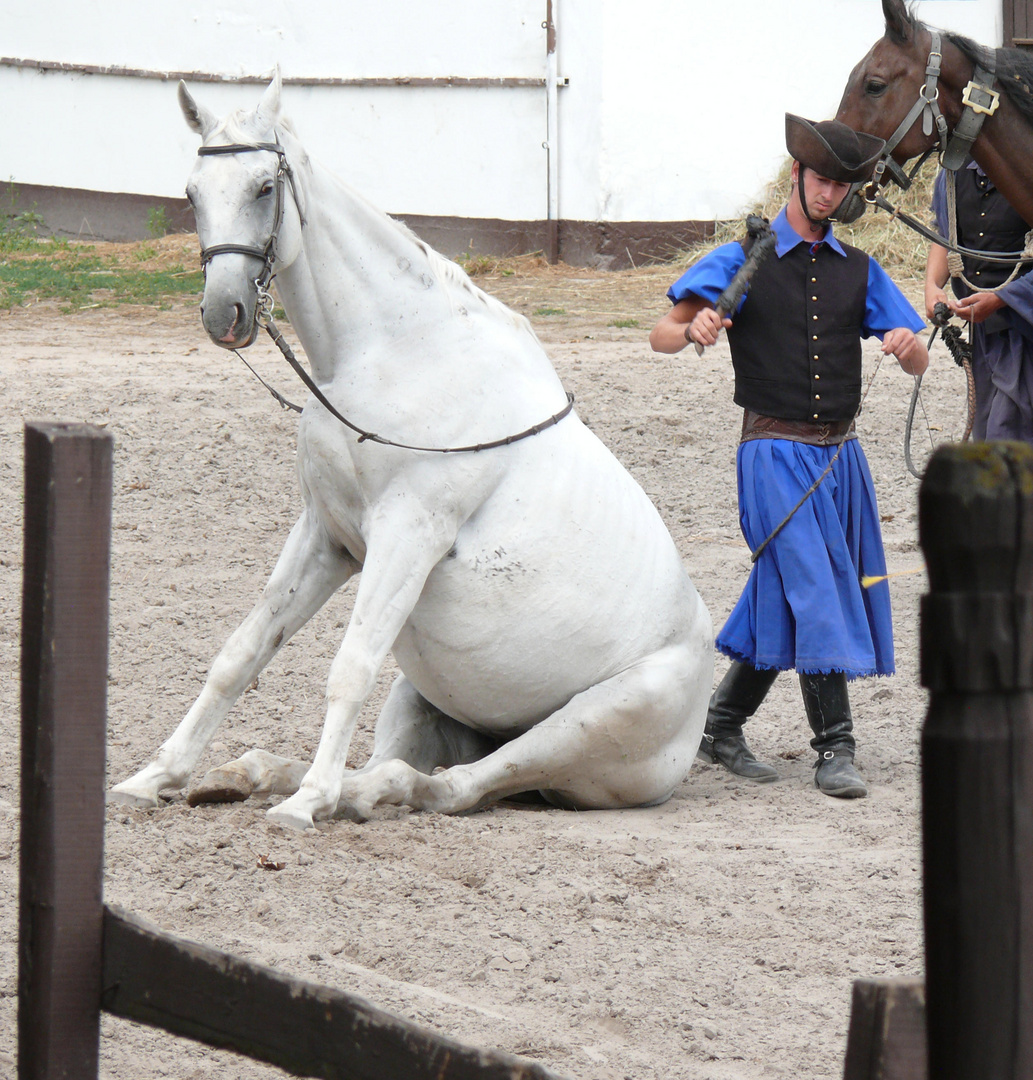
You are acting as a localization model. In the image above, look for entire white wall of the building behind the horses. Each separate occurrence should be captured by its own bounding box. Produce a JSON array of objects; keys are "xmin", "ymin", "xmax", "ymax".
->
[{"xmin": 0, "ymin": 0, "xmax": 1002, "ymax": 221}]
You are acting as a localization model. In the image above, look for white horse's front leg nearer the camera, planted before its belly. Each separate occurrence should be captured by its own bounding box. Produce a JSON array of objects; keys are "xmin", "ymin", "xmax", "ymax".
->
[{"xmin": 268, "ymin": 499, "xmax": 455, "ymax": 828}]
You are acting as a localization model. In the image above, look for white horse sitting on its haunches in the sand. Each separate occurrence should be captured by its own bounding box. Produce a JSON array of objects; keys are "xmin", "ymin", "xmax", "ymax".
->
[{"xmin": 111, "ymin": 72, "xmax": 713, "ymax": 828}]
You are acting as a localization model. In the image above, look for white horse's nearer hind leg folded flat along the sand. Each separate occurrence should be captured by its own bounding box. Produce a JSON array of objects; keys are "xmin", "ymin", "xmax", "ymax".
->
[{"xmin": 338, "ymin": 639, "xmax": 713, "ymax": 818}]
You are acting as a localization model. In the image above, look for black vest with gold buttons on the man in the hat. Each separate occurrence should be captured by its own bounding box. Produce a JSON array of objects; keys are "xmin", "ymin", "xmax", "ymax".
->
[{"xmin": 728, "ymin": 243, "xmax": 868, "ymax": 422}]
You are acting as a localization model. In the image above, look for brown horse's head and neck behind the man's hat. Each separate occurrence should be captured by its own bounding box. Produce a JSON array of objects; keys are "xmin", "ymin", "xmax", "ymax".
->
[{"xmin": 836, "ymin": 0, "xmax": 1033, "ymax": 226}]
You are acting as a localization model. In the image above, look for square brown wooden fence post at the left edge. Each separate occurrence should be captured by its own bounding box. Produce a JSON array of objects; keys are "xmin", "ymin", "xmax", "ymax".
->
[{"xmin": 18, "ymin": 423, "xmax": 111, "ymax": 1080}]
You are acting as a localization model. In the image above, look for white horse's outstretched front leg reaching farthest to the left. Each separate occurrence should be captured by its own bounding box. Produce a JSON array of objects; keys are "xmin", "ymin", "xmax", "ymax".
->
[{"xmin": 108, "ymin": 511, "xmax": 360, "ymax": 807}]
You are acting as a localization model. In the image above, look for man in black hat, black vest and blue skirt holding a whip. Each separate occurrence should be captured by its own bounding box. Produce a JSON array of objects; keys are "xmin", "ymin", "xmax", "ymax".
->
[{"xmin": 649, "ymin": 114, "xmax": 929, "ymax": 798}]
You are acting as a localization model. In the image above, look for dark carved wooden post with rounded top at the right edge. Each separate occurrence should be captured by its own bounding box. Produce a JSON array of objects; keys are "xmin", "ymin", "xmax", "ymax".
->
[{"xmin": 918, "ymin": 443, "xmax": 1033, "ymax": 1080}]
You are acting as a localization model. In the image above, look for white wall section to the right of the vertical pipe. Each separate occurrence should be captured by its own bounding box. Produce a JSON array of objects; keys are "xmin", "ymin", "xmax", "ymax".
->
[{"xmin": 560, "ymin": 0, "xmax": 1002, "ymax": 221}]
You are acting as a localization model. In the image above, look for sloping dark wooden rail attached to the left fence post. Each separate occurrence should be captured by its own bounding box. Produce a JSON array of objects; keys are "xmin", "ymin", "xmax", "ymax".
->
[{"xmin": 102, "ymin": 907, "xmax": 574, "ymax": 1080}]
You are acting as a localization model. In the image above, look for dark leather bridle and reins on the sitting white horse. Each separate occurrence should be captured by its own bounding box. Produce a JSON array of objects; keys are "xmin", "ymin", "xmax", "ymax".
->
[{"xmin": 198, "ymin": 143, "xmax": 574, "ymax": 454}]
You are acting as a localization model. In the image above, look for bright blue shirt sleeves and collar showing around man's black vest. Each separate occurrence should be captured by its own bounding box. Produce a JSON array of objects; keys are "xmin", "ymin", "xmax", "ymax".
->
[{"xmin": 667, "ymin": 208, "xmax": 925, "ymax": 338}]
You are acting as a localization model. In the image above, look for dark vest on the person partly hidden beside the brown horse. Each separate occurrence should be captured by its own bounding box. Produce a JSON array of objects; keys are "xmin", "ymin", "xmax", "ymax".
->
[{"xmin": 951, "ymin": 168, "xmax": 1029, "ymax": 304}]
